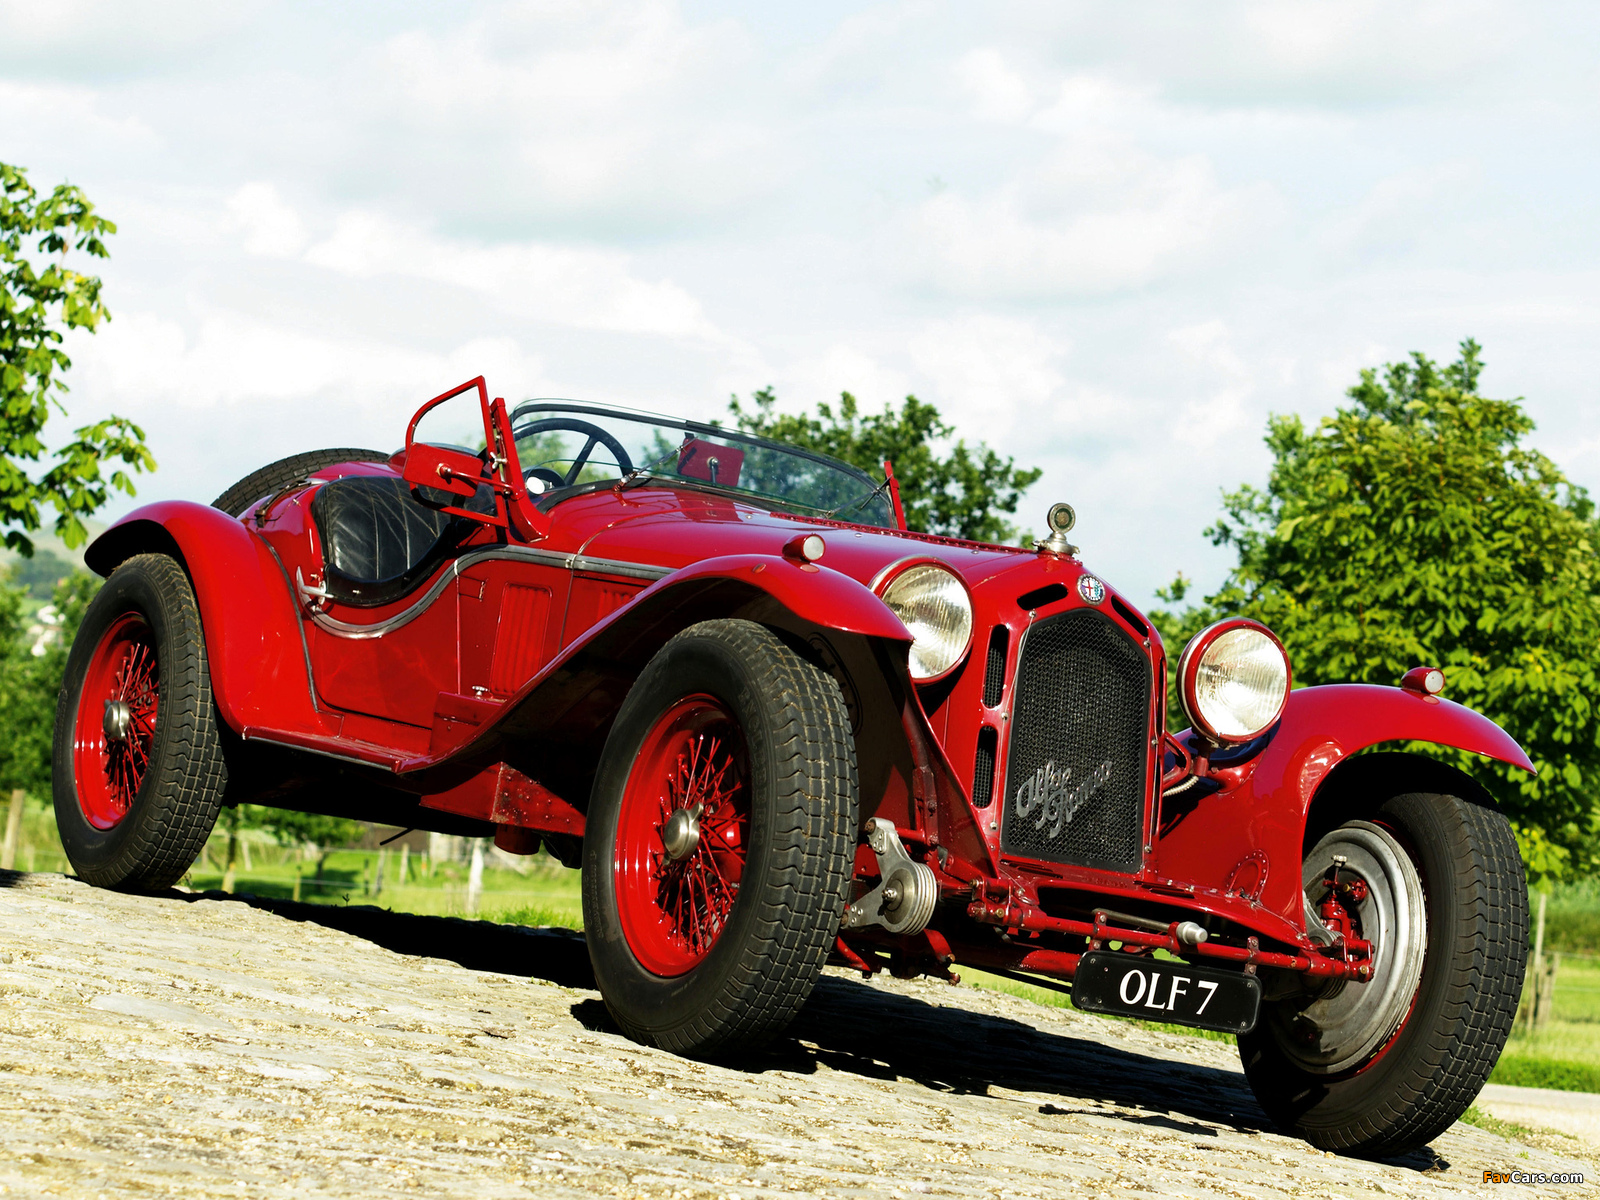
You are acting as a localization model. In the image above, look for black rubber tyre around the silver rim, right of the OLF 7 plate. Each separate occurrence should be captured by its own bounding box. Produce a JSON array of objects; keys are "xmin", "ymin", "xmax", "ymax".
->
[{"xmin": 1238, "ymin": 792, "xmax": 1528, "ymax": 1158}]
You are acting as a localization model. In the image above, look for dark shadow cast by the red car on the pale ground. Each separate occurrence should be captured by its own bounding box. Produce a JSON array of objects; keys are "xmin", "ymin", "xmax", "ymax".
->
[{"xmin": 187, "ymin": 891, "xmax": 1448, "ymax": 1171}]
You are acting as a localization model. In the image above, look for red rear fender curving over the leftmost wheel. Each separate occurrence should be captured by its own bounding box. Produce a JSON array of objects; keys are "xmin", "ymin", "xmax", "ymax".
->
[{"xmin": 83, "ymin": 501, "xmax": 325, "ymax": 731}]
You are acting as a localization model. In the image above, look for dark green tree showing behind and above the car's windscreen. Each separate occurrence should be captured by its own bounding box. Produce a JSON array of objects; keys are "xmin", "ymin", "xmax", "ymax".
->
[{"xmin": 728, "ymin": 387, "xmax": 1045, "ymax": 542}]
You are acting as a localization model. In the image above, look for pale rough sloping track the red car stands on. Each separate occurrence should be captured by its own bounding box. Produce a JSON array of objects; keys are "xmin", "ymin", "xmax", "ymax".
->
[{"xmin": 0, "ymin": 874, "xmax": 1600, "ymax": 1200}]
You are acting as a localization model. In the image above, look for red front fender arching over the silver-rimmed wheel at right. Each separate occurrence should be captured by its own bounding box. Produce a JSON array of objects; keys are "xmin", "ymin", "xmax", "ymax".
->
[{"xmin": 1155, "ymin": 683, "xmax": 1534, "ymax": 931}]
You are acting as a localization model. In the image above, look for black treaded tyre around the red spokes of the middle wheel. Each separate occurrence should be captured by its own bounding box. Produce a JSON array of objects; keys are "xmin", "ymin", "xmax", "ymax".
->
[{"xmin": 582, "ymin": 621, "xmax": 858, "ymax": 1058}]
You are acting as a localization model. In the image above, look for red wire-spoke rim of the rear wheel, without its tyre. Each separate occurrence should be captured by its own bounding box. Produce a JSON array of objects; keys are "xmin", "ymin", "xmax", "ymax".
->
[{"xmin": 72, "ymin": 613, "xmax": 160, "ymax": 829}]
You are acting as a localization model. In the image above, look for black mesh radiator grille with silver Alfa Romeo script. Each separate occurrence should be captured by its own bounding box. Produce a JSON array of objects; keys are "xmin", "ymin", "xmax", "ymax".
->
[{"xmin": 1000, "ymin": 608, "xmax": 1150, "ymax": 870}]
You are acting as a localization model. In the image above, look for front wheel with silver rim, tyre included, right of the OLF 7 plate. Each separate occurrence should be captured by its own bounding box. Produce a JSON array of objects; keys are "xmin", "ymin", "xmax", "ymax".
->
[{"xmin": 1238, "ymin": 792, "xmax": 1528, "ymax": 1158}]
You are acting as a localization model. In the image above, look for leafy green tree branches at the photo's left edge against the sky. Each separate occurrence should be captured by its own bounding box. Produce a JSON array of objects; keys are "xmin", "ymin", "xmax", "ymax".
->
[{"xmin": 0, "ymin": 163, "xmax": 155, "ymax": 555}]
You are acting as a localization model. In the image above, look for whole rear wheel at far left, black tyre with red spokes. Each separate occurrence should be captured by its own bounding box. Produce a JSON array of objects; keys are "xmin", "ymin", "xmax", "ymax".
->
[{"xmin": 51, "ymin": 554, "xmax": 227, "ymax": 891}]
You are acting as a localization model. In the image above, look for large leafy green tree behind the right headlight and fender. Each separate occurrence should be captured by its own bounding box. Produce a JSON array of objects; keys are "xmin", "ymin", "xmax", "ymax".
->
[{"xmin": 1157, "ymin": 341, "xmax": 1600, "ymax": 875}]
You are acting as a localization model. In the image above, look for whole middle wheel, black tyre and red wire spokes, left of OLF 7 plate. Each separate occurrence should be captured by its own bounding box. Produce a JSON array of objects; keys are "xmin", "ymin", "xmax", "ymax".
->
[{"xmin": 584, "ymin": 621, "xmax": 858, "ymax": 1056}]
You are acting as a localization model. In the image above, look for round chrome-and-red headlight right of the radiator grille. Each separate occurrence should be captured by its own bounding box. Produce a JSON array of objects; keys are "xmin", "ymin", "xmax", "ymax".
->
[{"xmin": 1178, "ymin": 618, "xmax": 1290, "ymax": 744}]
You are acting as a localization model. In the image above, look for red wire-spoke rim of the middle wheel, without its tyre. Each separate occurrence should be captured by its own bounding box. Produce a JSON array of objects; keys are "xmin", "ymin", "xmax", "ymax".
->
[{"xmin": 616, "ymin": 696, "xmax": 750, "ymax": 976}]
